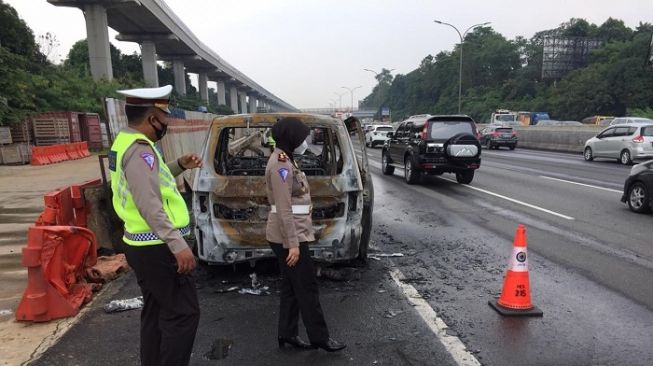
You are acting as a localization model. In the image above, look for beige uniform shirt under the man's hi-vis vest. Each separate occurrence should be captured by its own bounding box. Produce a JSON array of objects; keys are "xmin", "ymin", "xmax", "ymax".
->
[{"xmin": 121, "ymin": 127, "xmax": 188, "ymax": 254}]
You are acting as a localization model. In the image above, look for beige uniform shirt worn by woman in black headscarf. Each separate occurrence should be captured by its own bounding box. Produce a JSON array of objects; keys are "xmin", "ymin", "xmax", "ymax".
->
[{"xmin": 265, "ymin": 148, "xmax": 315, "ymax": 248}]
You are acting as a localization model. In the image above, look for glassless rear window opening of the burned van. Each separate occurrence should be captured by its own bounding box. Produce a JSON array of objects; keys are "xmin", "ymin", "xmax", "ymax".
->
[{"xmin": 214, "ymin": 127, "xmax": 342, "ymax": 176}]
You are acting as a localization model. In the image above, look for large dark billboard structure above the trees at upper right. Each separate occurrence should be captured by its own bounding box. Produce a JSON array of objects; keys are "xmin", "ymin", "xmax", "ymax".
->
[{"xmin": 542, "ymin": 35, "xmax": 603, "ymax": 79}]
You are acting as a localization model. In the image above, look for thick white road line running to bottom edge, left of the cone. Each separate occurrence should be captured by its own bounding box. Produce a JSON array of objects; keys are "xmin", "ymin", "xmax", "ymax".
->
[{"xmin": 390, "ymin": 268, "xmax": 481, "ymax": 366}]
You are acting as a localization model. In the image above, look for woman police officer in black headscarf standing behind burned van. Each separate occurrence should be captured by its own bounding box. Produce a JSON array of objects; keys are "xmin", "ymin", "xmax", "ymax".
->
[{"xmin": 265, "ymin": 117, "xmax": 345, "ymax": 352}]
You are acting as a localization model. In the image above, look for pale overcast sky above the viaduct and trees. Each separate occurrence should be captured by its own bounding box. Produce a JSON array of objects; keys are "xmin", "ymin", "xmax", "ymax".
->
[{"xmin": 4, "ymin": 0, "xmax": 653, "ymax": 108}]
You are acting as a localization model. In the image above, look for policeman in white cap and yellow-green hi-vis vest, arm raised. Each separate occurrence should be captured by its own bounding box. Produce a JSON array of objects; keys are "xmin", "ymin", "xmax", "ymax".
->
[{"xmin": 109, "ymin": 85, "xmax": 202, "ymax": 366}]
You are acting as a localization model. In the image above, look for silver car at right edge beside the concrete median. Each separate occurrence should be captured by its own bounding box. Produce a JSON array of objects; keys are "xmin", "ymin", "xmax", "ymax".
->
[{"xmin": 583, "ymin": 123, "xmax": 653, "ymax": 165}]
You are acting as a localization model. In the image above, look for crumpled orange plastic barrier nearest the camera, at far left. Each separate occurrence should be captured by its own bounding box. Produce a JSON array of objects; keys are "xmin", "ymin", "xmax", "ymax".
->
[{"xmin": 16, "ymin": 226, "xmax": 97, "ymax": 322}]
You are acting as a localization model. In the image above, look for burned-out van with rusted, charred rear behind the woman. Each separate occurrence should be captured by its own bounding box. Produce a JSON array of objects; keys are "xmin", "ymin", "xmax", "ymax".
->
[{"xmin": 192, "ymin": 113, "xmax": 374, "ymax": 264}]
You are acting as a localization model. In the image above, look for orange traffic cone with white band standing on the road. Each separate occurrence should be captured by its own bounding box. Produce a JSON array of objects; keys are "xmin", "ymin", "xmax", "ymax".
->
[{"xmin": 489, "ymin": 224, "xmax": 544, "ymax": 316}]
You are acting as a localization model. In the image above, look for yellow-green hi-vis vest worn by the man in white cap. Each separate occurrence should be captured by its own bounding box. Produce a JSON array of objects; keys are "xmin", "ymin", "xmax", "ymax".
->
[{"xmin": 108, "ymin": 131, "xmax": 190, "ymax": 246}]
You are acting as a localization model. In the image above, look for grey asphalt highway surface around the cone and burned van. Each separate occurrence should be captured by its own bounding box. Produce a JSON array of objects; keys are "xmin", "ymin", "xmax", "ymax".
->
[{"xmin": 35, "ymin": 148, "xmax": 653, "ymax": 366}]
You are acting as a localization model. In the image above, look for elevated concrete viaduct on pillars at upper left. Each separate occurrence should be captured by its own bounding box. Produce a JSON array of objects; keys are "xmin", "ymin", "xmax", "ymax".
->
[{"xmin": 48, "ymin": 0, "xmax": 297, "ymax": 113}]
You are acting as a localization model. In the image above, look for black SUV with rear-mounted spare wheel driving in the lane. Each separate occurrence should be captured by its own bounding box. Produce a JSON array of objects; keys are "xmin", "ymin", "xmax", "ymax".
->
[{"xmin": 381, "ymin": 115, "xmax": 481, "ymax": 184}]
